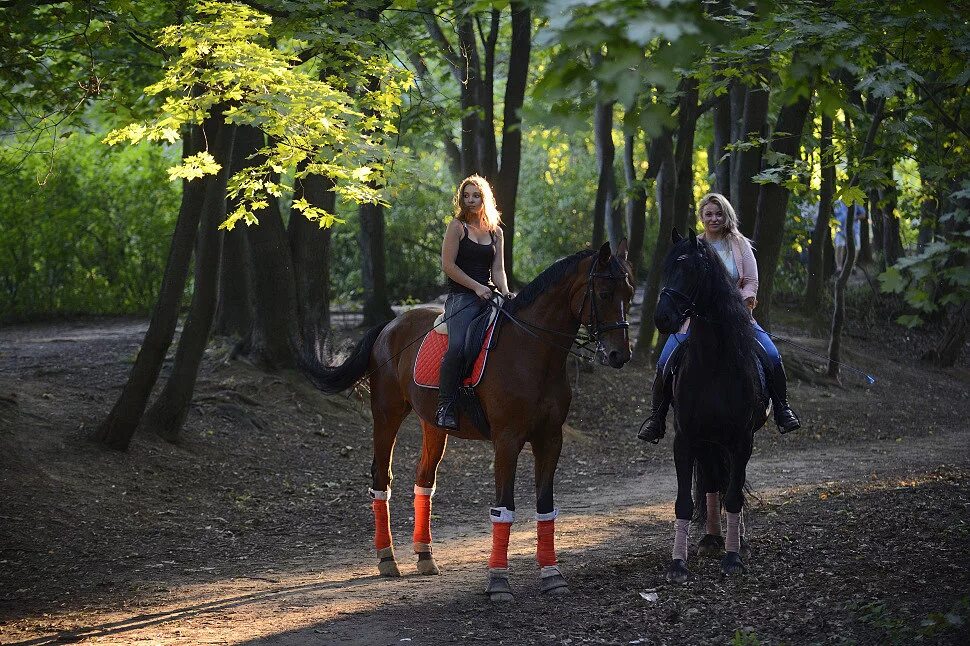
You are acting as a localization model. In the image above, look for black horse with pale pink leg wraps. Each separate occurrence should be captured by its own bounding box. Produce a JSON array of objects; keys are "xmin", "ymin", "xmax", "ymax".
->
[{"xmin": 654, "ymin": 229, "xmax": 769, "ymax": 583}]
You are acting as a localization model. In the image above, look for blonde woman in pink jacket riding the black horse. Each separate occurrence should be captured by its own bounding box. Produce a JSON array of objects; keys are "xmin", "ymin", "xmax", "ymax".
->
[{"xmin": 637, "ymin": 193, "xmax": 801, "ymax": 443}]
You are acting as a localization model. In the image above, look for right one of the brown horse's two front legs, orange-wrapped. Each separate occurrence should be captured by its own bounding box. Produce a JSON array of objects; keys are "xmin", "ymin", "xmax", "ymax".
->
[{"xmin": 531, "ymin": 425, "xmax": 569, "ymax": 596}]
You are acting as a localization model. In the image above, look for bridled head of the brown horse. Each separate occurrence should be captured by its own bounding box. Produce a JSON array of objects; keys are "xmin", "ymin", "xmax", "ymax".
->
[{"xmin": 571, "ymin": 239, "xmax": 634, "ymax": 368}]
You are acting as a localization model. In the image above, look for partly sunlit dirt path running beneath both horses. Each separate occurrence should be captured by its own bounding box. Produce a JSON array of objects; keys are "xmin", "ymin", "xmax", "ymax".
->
[{"xmin": 4, "ymin": 433, "xmax": 970, "ymax": 645}]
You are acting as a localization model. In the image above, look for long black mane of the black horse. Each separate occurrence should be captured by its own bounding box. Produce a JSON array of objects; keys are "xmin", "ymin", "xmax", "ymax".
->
[{"xmin": 664, "ymin": 238, "xmax": 757, "ymax": 380}]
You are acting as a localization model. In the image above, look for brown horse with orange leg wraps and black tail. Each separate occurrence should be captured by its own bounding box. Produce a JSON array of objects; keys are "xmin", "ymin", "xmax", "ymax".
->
[{"xmin": 302, "ymin": 240, "xmax": 634, "ymax": 601}]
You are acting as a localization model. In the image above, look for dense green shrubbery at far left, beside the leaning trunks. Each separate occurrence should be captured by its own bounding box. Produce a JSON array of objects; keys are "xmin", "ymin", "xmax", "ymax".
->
[{"xmin": 0, "ymin": 135, "xmax": 179, "ymax": 320}]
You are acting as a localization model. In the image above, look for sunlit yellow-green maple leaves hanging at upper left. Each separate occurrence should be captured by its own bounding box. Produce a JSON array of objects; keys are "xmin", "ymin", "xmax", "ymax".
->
[{"xmin": 105, "ymin": 1, "xmax": 410, "ymax": 229}]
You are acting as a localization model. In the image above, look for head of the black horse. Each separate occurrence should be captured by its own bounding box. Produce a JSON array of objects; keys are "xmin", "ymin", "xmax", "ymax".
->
[{"xmin": 653, "ymin": 229, "xmax": 710, "ymax": 334}]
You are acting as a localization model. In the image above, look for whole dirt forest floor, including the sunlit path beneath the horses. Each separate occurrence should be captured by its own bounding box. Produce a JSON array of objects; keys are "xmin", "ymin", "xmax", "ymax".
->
[{"xmin": 0, "ymin": 306, "xmax": 970, "ymax": 645}]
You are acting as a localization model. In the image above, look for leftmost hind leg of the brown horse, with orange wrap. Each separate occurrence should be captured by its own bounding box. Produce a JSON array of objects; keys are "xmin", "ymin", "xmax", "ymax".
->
[{"xmin": 370, "ymin": 390, "xmax": 411, "ymax": 576}]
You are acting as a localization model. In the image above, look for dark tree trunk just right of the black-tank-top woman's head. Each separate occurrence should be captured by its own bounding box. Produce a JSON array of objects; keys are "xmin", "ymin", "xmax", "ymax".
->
[{"xmin": 496, "ymin": 2, "xmax": 532, "ymax": 285}]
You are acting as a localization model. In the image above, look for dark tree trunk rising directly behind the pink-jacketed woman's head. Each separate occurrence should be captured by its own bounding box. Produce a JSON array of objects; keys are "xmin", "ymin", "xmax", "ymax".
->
[{"xmin": 731, "ymin": 87, "xmax": 768, "ymax": 238}]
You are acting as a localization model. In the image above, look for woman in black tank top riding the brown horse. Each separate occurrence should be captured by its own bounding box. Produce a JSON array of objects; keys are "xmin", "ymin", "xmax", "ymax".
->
[{"xmin": 435, "ymin": 175, "xmax": 509, "ymax": 430}]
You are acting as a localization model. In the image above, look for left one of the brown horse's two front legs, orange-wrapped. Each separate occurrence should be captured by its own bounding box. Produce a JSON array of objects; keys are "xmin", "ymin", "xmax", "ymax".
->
[{"xmin": 485, "ymin": 432, "xmax": 524, "ymax": 601}]
